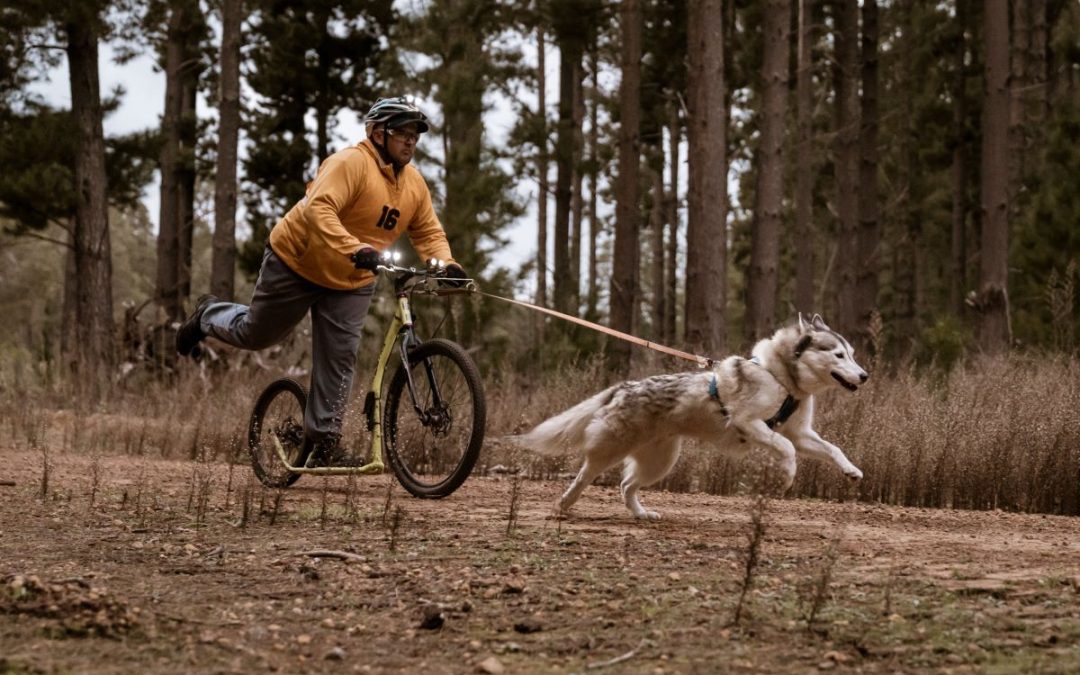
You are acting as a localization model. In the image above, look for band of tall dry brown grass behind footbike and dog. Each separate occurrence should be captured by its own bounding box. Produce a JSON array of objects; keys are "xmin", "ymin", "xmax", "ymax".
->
[{"xmin": 0, "ymin": 347, "xmax": 1080, "ymax": 514}]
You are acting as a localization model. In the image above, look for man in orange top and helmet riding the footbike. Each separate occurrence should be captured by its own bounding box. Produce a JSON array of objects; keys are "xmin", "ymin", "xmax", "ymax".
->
[{"xmin": 176, "ymin": 97, "xmax": 465, "ymax": 465}]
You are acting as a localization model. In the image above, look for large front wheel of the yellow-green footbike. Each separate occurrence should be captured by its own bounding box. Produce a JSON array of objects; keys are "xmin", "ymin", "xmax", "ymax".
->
[{"xmin": 384, "ymin": 339, "xmax": 486, "ymax": 499}]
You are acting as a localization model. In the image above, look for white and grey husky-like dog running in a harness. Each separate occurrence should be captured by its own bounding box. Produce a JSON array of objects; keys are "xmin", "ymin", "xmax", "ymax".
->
[{"xmin": 513, "ymin": 314, "xmax": 869, "ymax": 521}]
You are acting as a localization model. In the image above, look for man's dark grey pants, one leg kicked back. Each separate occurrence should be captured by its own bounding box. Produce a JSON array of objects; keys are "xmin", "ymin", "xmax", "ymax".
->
[{"xmin": 202, "ymin": 246, "xmax": 375, "ymax": 443}]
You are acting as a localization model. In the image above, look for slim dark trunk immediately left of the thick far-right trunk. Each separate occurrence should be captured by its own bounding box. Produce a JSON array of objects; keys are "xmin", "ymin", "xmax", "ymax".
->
[{"xmin": 948, "ymin": 0, "xmax": 970, "ymax": 316}]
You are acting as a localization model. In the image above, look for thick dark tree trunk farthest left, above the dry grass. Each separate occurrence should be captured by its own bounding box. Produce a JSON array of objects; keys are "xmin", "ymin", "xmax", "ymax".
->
[{"xmin": 66, "ymin": 11, "xmax": 116, "ymax": 384}]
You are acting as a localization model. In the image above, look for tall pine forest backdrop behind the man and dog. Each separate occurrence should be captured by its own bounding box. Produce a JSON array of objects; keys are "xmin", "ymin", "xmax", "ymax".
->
[{"xmin": 0, "ymin": 0, "xmax": 1080, "ymax": 391}]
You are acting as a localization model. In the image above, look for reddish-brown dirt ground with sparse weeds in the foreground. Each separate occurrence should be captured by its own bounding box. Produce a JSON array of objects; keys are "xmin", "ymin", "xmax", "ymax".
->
[{"xmin": 0, "ymin": 448, "xmax": 1080, "ymax": 673}]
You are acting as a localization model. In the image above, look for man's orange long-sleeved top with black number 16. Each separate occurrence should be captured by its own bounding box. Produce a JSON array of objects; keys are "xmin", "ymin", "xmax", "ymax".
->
[{"xmin": 270, "ymin": 140, "xmax": 454, "ymax": 291}]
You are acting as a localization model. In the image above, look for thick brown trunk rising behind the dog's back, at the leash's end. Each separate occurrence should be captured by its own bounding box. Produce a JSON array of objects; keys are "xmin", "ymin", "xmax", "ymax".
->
[{"xmin": 685, "ymin": 0, "xmax": 728, "ymax": 354}]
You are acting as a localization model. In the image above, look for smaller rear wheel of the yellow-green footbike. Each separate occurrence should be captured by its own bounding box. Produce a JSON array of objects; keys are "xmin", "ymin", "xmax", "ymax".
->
[{"xmin": 247, "ymin": 378, "xmax": 308, "ymax": 487}]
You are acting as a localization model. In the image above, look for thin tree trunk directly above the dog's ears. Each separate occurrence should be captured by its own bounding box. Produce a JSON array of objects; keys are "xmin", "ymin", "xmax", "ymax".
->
[{"xmin": 795, "ymin": 0, "xmax": 814, "ymax": 313}]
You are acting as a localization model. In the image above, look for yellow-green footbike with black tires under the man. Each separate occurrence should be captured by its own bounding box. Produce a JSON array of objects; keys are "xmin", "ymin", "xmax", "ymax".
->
[{"xmin": 247, "ymin": 260, "xmax": 486, "ymax": 499}]
